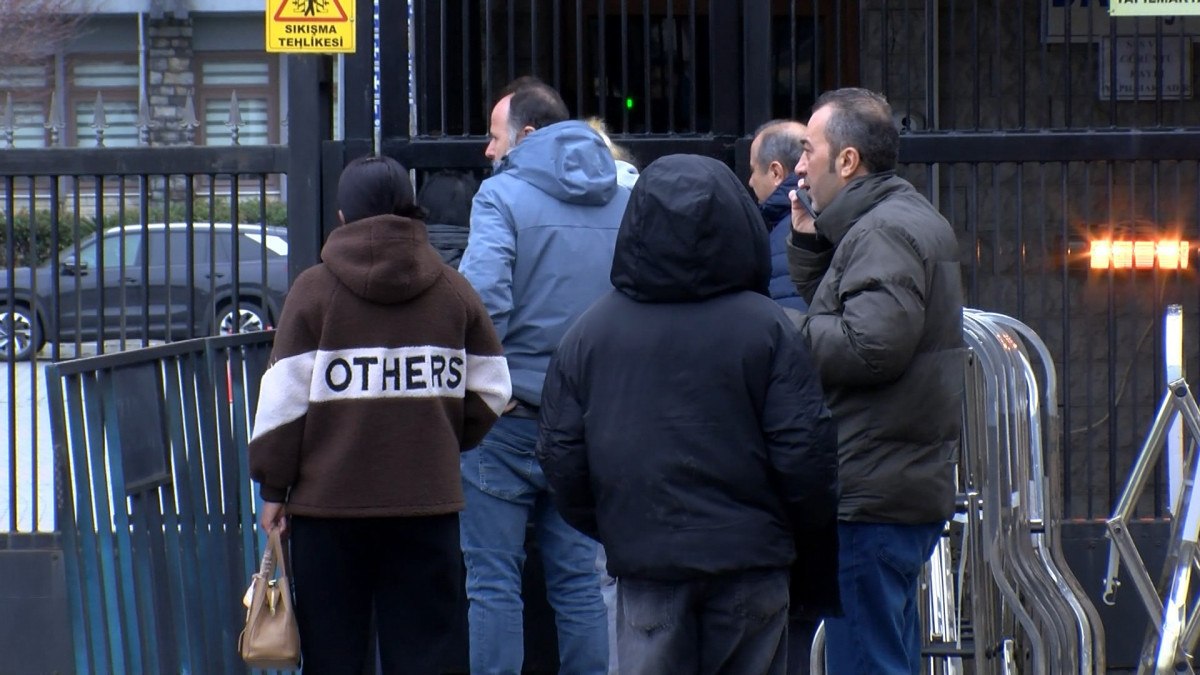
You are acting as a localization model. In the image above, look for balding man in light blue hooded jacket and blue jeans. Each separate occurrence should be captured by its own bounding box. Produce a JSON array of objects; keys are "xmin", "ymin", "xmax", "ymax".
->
[{"xmin": 460, "ymin": 78, "xmax": 629, "ymax": 675}]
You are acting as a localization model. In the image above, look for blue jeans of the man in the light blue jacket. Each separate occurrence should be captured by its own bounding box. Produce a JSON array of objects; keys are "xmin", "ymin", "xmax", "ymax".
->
[{"xmin": 461, "ymin": 417, "xmax": 608, "ymax": 675}]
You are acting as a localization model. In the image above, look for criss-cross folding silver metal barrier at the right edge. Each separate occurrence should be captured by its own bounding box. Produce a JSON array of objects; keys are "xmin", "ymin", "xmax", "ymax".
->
[{"xmin": 1104, "ymin": 305, "xmax": 1200, "ymax": 674}]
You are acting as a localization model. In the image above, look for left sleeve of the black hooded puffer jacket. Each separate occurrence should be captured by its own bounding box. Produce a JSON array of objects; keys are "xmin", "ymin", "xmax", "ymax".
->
[{"xmin": 538, "ymin": 331, "xmax": 599, "ymax": 539}]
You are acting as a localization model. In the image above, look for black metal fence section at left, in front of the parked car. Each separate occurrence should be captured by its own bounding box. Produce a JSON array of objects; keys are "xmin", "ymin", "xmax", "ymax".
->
[{"xmin": 0, "ymin": 147, "xmax": 288, "ymax": 532}]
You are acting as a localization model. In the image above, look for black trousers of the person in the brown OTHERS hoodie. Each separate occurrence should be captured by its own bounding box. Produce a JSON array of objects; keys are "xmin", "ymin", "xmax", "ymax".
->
[{"xmin": 290, "ymin": 514, "xmax": 462, "ymax": 675}]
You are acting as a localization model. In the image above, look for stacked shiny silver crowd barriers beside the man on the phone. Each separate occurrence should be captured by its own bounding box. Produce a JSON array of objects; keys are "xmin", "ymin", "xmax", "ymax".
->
[{"xmin": 810, "ymin": 310, "xmax": 1105, "ymax": 675}]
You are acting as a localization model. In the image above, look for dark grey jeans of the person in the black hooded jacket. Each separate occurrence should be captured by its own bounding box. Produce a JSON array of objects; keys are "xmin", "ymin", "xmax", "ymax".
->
[{"xmin": 617, "ymin": 569, "xmax": 790, "ymax": 675}]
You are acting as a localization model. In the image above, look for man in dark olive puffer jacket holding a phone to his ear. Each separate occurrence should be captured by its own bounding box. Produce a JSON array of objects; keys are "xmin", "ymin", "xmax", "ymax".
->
[{"xmin": 788, "ymin": 88, "xmax": 964, "ymax": 675}]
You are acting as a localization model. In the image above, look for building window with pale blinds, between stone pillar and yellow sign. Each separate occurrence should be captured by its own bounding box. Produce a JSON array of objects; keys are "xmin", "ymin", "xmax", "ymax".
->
[{"xmin": 197, "ymin": 54, "xmax": 278, "ymax": 145}]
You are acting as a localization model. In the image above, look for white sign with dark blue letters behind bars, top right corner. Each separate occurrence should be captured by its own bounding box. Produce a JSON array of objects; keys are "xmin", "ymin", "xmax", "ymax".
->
[{"xmin": 1042, "ymin": 0, "xmax": 1200, "ymax": 42}]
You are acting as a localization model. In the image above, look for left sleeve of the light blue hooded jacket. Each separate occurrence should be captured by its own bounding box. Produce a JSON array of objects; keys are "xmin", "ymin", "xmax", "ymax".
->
[{"xmin": 458, "ymin": 182, "xmax": 517, "ymax": 342}]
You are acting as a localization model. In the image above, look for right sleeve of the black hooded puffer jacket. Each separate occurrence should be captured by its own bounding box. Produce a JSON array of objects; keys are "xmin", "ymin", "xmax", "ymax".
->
[{"xmin": 762, "ymin": 317, "xmax": 838, "ymax": 528}]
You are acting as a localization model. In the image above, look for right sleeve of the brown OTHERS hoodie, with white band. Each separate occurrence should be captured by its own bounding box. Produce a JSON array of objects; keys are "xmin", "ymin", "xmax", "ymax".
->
[{"xmin": 462, "ymin": 288, "xmax": 512, "ymax": 450}]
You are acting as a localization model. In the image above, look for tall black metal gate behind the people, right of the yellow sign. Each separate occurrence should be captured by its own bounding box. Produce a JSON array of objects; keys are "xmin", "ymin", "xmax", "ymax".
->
[{"xmin": 346, "ymin": 0, "xmax": 1200, "ymax": 519}]
